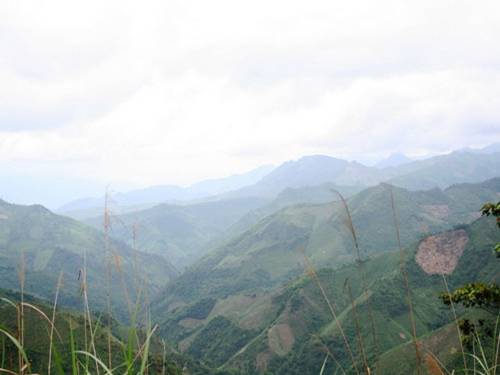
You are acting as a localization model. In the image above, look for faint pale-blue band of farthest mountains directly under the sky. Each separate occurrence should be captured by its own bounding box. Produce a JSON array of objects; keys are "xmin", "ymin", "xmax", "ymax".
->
[{"xmin": 57, "ymin": 144, "xmax": 500, "ymax": 219}]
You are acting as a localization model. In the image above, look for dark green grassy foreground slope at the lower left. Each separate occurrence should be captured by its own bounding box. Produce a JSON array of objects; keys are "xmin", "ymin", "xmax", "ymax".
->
[{"xmin": 0, "ymin": 289, "xmax": 212, "ymax": 375}]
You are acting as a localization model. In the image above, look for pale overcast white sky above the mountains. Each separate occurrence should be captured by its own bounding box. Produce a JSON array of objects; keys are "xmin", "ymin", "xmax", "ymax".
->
[{"xmin": 0, "ymin": 0, "xmax": 500, "ymax": 204}]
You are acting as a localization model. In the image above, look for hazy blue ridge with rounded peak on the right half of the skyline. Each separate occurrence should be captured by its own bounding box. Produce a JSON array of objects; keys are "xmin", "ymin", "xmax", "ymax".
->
[{"xmin": 224, "ymin": 151, "xmax": 500, "ymax": 198}]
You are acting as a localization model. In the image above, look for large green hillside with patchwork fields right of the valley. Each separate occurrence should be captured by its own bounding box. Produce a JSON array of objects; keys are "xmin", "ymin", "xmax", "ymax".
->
[{"xmin": 153, "ymin": 179, "xmax": 500, "ymax": 374}]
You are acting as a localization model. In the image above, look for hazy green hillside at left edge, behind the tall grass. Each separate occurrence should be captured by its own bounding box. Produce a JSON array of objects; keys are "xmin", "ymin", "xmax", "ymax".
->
[{"xmin": 0, "ymin": 201, "xmax": 176, "ymax": 316}]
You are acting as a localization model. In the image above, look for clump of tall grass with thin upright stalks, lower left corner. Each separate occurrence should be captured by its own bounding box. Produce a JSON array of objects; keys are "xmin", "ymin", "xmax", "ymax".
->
[{"xmin": 0, "ymin": 192, "xmax": 167, "ymax": 375}]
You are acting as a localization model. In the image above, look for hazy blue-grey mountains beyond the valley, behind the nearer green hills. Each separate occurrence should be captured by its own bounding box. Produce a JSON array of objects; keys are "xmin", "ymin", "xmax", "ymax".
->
[{"xmin": 73, "ymin": 151, "xmax": 500, "ymax": 269}]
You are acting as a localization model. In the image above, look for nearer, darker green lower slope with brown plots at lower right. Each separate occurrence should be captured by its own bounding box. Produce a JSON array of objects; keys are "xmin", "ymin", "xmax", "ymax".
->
[{"xmin": 154, "ymin": 219, "xmax": 500, "ymax": 374}]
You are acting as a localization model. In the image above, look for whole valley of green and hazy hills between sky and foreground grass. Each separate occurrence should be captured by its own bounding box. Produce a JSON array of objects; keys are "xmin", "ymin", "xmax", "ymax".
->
[{"xmin": 0, "ymin": 152, "xmax": 500, "ymax": 375}]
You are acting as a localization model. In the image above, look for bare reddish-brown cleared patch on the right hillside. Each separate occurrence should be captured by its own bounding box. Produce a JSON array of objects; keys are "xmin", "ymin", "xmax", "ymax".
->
[{"xmin": 415, "ymin": 229, "xmax": 469, "ymax": 275}]
